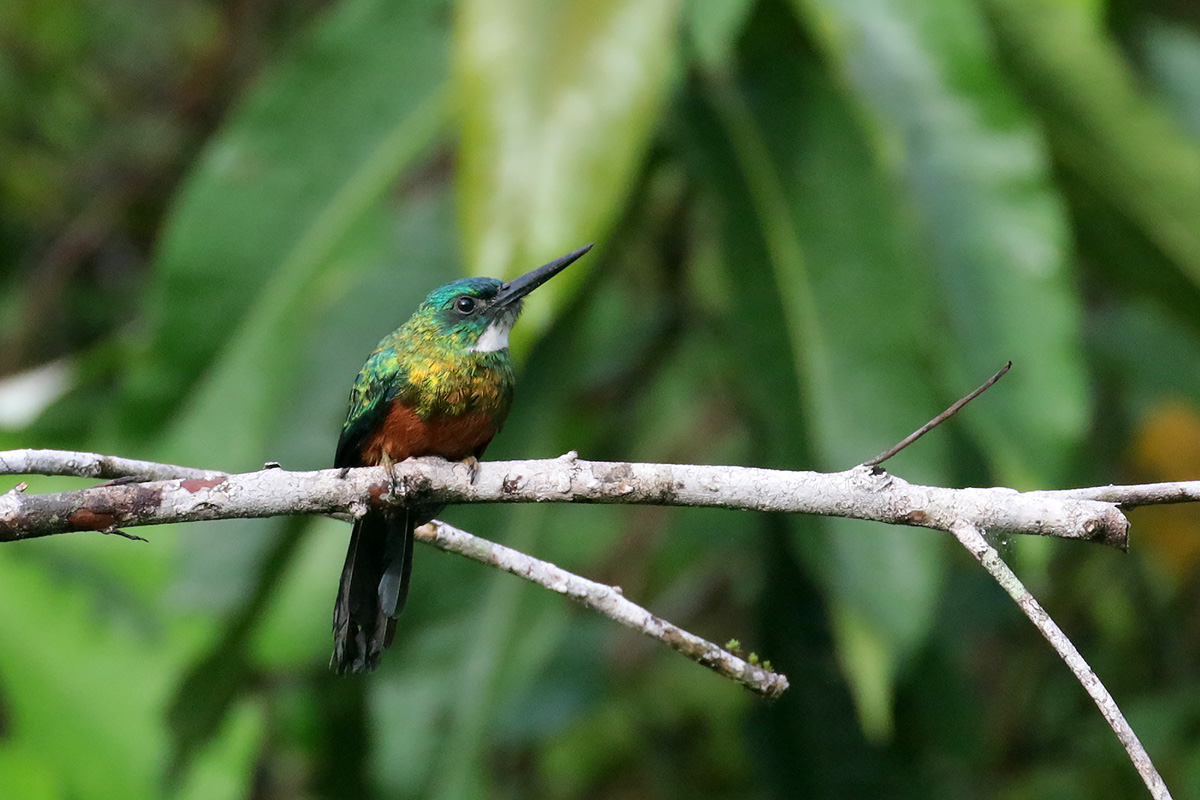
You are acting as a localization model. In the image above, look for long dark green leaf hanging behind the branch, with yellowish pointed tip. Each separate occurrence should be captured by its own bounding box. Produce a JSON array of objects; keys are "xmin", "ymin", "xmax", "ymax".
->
[{"xmin": 691, "ymin": 3, "xmax": 946, "ymax": 734}]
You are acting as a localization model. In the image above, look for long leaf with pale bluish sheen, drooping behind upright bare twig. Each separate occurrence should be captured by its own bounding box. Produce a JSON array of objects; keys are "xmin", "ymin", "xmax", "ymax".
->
[{"xmin": 793, "ymin": 0, "xmax": 1090, "ymax": 486}]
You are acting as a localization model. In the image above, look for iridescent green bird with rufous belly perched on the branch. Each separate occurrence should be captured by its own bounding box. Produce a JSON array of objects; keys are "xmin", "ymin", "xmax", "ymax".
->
[{"xmin": 330, "ymin": 245, "xmax": 592, "ymax": 674}]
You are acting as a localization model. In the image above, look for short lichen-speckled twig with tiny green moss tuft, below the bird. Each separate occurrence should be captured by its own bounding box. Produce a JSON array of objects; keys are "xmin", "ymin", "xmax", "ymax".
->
[{"xmin": 416, "ymin": 521, "xmax": 787, "ymax": 697}]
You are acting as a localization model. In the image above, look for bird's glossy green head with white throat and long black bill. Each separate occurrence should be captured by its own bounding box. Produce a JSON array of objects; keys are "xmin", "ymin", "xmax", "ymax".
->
[{"xmin": 414, "ymin": 245, "xmax": 592, "ymax": 353}]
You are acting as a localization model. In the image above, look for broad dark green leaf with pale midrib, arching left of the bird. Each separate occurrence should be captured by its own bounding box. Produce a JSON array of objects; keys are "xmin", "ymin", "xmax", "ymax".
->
[{"xmin": 121, "ymin": 0, "xmax": 448, "ymax": 453}]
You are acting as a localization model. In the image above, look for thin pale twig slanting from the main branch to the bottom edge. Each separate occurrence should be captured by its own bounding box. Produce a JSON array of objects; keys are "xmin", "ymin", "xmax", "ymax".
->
[{"xmin": 952, "ymin": 524, "xmax": 1171, "ymax": 800}]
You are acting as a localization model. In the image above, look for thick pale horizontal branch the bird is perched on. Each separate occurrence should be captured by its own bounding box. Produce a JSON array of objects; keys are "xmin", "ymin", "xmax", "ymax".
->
[{"xmin": 0, "ymin": 453, "xmax": 1128, "ymax": 549}]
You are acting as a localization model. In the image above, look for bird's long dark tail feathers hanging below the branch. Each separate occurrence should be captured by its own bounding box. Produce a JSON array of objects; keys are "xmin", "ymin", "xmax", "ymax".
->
[{"xmin": 329, "ymin": 509, "xmax": 415, "ymax": 675}]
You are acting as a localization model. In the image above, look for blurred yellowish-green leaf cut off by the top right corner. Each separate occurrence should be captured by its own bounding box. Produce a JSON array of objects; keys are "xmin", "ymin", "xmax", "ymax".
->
[{"xmin": 985, "ymin": 0, "xmax": 1200, "ymax": 350}]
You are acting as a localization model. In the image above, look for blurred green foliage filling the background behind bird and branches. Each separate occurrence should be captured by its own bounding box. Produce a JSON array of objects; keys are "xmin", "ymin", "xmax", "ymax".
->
[{"xmin": 0, "ymin": 0, "xmax": 1200, "ymax": 800}]
